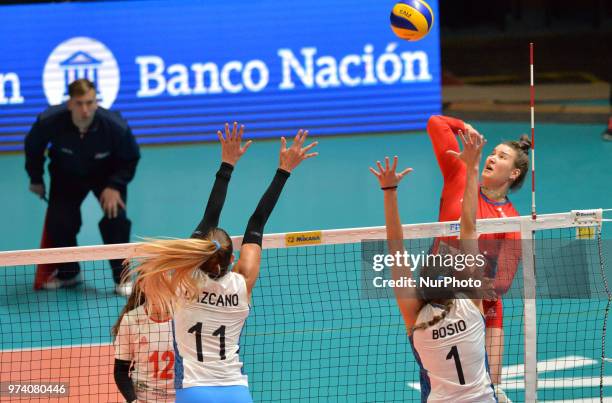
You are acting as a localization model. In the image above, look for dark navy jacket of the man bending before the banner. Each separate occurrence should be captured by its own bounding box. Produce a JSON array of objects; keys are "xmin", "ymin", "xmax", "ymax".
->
[{"xmin": 25, "ymin": 105, "xmax": 140, "ymax": 190}]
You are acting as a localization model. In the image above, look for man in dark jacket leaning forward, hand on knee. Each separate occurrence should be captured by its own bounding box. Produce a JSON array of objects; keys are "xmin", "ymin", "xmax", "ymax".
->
[{"xmin": 25, "ymin": 79, "xmax": 140, "ymax": 295}]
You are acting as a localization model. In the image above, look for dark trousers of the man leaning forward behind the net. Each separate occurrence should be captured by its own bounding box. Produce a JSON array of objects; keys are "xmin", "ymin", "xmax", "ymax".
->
[{"xmin": 45, "ymin": 176, "xmax": 131, "ymax": 283}]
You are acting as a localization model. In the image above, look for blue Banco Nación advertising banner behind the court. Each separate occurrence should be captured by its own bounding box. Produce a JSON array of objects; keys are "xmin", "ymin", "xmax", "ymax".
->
[{"xmin": 0, "ymin": 0, "xmax": 441, "ymax": 151}]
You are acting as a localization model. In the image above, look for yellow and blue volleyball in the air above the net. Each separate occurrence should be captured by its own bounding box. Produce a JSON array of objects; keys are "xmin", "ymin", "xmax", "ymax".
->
[{"xmin": 390, "ymin": 0, "xmax": 434, "ymax": 41}]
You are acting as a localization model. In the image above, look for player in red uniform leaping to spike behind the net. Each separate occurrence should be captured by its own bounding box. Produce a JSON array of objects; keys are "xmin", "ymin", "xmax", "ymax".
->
[{"xmin": 427, "ymin": 116, "xmax": 531, "ymax": 402}]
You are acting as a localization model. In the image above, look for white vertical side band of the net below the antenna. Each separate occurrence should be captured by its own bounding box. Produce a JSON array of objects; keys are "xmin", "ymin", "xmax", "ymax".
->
[{"xmin": 521, "ymin": 217, "xmax": 538, "ymax": 402}]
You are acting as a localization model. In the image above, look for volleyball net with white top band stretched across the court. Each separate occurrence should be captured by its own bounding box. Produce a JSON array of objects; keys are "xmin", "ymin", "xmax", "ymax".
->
[{"xmin": 0, "ymin": 210, "xmax": 612, "ymax": 402}]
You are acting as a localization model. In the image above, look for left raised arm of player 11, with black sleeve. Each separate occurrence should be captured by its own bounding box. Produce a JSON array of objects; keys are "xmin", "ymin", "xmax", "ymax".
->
[{"xmin": 191, "ymin": 122, "xmax": 252, "ymax": 238}]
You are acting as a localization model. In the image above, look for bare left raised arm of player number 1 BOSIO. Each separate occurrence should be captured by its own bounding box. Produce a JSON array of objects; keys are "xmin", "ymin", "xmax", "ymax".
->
[{"xmin": 370, "ymin": 157, "xmax": 423, "ymax": 335}]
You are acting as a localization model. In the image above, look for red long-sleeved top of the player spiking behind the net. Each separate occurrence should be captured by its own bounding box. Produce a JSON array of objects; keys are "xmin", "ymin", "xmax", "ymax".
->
[{"xmin": 427, "ymin": 116, "xmax": 521, "ymax": 328}]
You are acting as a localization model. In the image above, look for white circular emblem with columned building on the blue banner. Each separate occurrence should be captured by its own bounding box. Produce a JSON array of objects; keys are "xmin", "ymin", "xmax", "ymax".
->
[{"xmin": 43, "ymin": 36, "xmax": 120, "ymax": 109}]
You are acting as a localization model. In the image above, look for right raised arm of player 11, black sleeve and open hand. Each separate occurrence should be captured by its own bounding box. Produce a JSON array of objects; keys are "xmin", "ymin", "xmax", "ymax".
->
[{"xmin": 235, "ymin": 130, "xmax": 318, "ymax": 298}]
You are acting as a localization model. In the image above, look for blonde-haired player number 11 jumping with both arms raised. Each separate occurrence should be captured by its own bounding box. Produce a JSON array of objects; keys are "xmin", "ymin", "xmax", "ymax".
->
[{"xmin": 128, "ymin": 124, "xmax": 317, "ymax": 403}]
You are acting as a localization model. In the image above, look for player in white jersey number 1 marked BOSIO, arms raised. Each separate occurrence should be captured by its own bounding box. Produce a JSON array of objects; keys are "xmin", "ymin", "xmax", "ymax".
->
[{"xmin": 370, "ymin": 130, "xmax": 497, "ymax": 403}]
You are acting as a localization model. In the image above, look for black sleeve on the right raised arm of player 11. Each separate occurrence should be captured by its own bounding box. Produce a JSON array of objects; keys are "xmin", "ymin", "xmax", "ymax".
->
[{"xmin": 242, "ymin": 169, "xmax": 290, "ymax": 246}]
